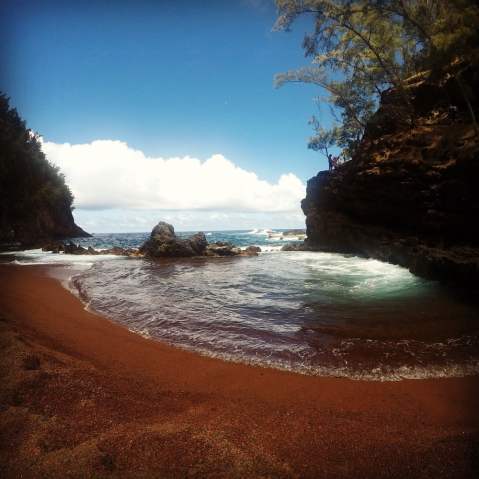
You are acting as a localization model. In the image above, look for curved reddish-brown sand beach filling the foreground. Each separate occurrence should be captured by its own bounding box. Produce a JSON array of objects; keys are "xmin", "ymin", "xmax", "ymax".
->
[{"xmin": 0, "ymin": 265, "xmax": 479, "ymax": 478}]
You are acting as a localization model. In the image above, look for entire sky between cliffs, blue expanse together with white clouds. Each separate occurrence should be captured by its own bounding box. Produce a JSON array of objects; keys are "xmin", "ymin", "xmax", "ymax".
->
[{"xmin": 0, "ymin": 0, "xmax": 332, "ymax": 232}]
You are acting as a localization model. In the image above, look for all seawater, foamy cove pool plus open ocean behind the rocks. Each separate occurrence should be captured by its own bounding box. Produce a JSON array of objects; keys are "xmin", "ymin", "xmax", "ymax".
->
[{"xmin": 7, "ymin": 230, "xmax": 479, "ymax": 380}]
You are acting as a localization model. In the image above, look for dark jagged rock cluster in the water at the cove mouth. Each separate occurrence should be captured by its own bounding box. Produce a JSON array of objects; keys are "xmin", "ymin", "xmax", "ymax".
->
[{"xmin": 140, "ymin": 221, "xmax": 261, "ymax": 258}]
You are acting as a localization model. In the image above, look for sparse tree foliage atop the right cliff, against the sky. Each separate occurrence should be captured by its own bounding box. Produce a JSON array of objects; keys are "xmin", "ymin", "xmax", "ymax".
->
[{"xmin": 275, "ymin": 0, "xmax": 479, "ymax": 161}]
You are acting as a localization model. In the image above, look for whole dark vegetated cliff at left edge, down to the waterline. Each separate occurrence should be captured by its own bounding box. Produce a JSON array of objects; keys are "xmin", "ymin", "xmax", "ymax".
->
[{"xmin": 0, "ymin": 94, "xmax": 86, "ymax": 244}]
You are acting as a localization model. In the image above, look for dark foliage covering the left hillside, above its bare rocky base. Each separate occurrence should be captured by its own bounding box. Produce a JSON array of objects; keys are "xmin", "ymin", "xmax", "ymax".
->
[{"xmin": 0, "ymin": 93, "xmax": 73, "ymax": 239}]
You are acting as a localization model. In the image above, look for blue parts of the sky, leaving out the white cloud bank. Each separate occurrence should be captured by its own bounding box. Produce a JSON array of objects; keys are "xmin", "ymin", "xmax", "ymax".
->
[{"xmin": 0, "ymin": 0, "xmax": 332, "ymax": 229}]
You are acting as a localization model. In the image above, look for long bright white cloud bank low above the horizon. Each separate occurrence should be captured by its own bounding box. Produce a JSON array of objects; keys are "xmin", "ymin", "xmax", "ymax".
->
[{"xmin": 42, "ymin": 140, "xmax": 305, "ymax": 215}]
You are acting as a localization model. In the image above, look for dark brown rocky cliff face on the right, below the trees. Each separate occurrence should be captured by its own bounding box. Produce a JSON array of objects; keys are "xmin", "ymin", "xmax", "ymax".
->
[{"xmin": 302, "ymin": 64, "xmax": 479, "ymax": 284}]
